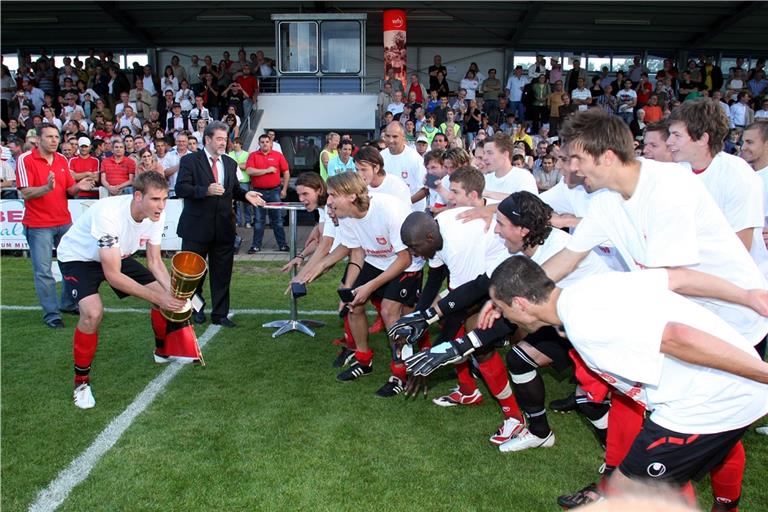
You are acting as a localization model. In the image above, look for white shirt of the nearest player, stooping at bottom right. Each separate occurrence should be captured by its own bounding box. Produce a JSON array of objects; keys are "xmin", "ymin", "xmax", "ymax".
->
[{"xmin": 557, "ymin": 269, "xmax": 768, "ymax": 434}]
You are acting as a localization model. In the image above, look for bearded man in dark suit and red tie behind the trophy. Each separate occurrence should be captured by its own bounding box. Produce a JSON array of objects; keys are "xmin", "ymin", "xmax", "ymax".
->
[{"xmin": 176, "ymin": 121, "xmax": 264, "ymax": 327}]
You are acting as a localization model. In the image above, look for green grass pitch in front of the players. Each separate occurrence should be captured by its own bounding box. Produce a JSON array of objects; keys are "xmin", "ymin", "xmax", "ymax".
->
[{"xmin": 0, "ymin": 257, "xmax": 768, "ymax": 511}]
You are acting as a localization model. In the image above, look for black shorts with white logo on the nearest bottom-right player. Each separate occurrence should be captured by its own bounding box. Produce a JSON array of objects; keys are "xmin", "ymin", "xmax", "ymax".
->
[{"xmin": 619, "ymin": 419, "xmax": 748, "ymax": 485}]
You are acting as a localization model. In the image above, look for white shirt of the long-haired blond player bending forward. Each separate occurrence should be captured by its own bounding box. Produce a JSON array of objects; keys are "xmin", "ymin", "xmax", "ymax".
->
[{"xmin": 338, "ymin": 194, "xmax": 424, "ymax": 272}]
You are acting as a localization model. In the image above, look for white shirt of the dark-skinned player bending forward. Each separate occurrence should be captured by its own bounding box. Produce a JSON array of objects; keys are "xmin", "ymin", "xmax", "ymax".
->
[{"xmin": 429, "ymin": 207, "xmax": 509, "ymax": 290}]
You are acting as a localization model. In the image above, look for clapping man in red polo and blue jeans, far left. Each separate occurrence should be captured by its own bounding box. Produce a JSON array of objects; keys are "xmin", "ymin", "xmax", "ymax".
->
[{"xmin": 16, "ymin": 125, "xmax": 94, "ymax": 329}]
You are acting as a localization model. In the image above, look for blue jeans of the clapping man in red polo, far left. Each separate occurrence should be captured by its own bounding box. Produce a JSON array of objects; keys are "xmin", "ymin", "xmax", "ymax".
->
[{"xmin": 24, "ymin": 224, "xmax": 77, "ymax": 323}]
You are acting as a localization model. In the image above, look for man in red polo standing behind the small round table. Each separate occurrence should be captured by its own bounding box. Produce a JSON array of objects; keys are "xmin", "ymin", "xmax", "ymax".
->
[{"xmin": 245, "ymin": 133, "xmax": 291, "ymax": 254}]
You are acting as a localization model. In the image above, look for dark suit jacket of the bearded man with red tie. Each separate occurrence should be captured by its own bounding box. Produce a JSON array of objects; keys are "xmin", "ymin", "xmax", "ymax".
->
[{"xmin": 176, "ymin": 150, "xmax": 246, "ymax": 244}]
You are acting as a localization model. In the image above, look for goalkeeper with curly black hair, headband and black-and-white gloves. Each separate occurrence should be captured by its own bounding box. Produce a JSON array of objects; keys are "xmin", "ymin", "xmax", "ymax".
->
[{"xmin": 401, "ymin": 191, "xmax": 609, "ymax": 452}]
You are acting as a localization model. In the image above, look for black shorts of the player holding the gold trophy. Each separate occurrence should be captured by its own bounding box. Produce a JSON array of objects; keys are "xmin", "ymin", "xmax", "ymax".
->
[{"xmin": 60, "ymin": 256, "xmax": 156, "ymax": 302}]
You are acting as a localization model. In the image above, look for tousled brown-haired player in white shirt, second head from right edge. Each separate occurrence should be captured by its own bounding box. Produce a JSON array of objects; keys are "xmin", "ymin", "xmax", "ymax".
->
[{"xmin": 667, "ymin": 98, "xmax": 768, "ymax": 275}]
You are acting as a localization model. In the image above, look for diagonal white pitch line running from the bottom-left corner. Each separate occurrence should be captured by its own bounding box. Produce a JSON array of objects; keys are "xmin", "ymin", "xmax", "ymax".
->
[{"xmin": 29, "ymin": 324, "xmax": 221, "ymax": 512}]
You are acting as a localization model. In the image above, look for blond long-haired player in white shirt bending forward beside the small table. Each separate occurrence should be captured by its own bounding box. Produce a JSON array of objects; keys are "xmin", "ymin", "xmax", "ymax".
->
[{"xmin": 306, "ymin": 172, "xmax": 423, "ymax": 397}]
